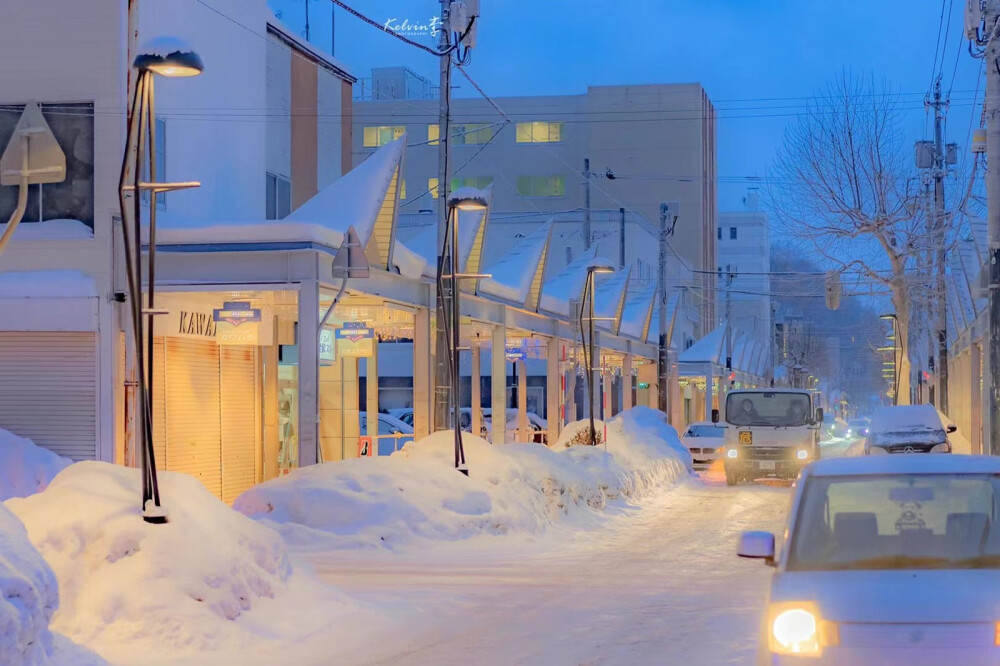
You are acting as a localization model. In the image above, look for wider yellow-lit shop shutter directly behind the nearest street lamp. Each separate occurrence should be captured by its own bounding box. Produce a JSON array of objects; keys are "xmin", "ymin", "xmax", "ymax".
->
[{"xmin": 164, "ymin": 338, "xmax": 222, "ymax": 497}]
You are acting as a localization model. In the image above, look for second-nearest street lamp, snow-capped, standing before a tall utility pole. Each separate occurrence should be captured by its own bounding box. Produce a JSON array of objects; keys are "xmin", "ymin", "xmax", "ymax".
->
[{"xmin": 437, "ymin": 187, "xmax": 496, "ymax": 476}]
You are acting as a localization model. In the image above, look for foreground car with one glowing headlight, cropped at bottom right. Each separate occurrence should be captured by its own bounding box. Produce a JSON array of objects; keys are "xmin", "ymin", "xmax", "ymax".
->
[{"xmin": 737, "ymin": 456, "xmax": 1000, "ymax": 666}]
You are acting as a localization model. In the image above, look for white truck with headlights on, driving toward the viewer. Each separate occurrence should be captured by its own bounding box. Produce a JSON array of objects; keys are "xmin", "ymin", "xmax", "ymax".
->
[{"xmin": 712, "ymin": 388, "xmax": 823, "ymax": 486}]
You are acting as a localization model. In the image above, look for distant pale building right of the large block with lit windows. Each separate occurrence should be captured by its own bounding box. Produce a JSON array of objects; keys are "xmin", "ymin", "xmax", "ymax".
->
[{"xmin": 715, "ymin": 190, "xmax": 772, "ymax": 339}]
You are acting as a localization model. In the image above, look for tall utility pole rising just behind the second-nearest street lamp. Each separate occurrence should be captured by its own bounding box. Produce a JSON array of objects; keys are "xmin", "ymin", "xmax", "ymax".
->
[{"xmin": 431, "ymin": 0, "xmax": 458, "ymax": 432}]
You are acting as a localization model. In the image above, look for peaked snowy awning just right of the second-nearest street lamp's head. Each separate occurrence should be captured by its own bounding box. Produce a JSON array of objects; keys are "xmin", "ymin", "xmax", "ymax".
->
[{"xmin": 478, "ymin": 220, "xmax": 552, "ymax": 310}]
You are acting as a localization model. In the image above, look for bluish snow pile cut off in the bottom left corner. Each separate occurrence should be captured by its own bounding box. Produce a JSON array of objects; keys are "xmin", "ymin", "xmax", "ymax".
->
[{"xmin": 0, "ymin": 504, "xmax": 59, "ymax": 664}]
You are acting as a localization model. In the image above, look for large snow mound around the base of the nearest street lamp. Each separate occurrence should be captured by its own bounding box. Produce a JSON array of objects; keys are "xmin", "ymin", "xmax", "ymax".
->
[{"xmin": 7, "ymin": 462, "xmax": 356, "ymax": 663}]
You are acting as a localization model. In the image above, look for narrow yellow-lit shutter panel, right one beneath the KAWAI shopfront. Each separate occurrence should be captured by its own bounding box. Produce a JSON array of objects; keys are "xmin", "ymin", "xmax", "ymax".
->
[{"xmin": 220, "ymin": 345, "xmax": 260, "ymax": 503}]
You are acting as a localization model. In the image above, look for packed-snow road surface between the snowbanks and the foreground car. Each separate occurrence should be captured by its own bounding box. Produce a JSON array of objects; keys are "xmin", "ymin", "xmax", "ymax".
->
[{"xmin": 296, "ymin": 473, "xmax": 789, "ymax": 664}]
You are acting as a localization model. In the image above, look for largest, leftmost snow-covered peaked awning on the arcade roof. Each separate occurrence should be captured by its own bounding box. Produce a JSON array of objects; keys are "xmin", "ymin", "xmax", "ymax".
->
[{"xmin": 284, "ymin": 134, "xmax": 406, "ymax": 270}]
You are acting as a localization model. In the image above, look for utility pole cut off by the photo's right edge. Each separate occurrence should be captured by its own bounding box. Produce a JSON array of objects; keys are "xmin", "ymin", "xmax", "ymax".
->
[{"xmin": 984, "ymin": 0, "xmax": 1000, "ymax": 455}]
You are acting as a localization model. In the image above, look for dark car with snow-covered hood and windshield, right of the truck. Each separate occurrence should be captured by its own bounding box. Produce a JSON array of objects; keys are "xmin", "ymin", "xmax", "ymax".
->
[{"xmin": 865, "ymin": 405, "xmax": 956, "ymax": 455}]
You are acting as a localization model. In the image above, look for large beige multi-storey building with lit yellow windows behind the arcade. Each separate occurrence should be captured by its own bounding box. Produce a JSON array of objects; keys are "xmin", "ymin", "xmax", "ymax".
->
[{"xmin": 354, "ymin": 68, "xmax": 717, "ymax": 334}]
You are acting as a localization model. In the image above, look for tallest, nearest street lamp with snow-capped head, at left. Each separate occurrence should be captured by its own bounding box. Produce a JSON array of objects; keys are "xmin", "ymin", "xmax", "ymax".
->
[{"xmin": 118, "ymin": 37, "xmax": 204, "ymax": 524}]
